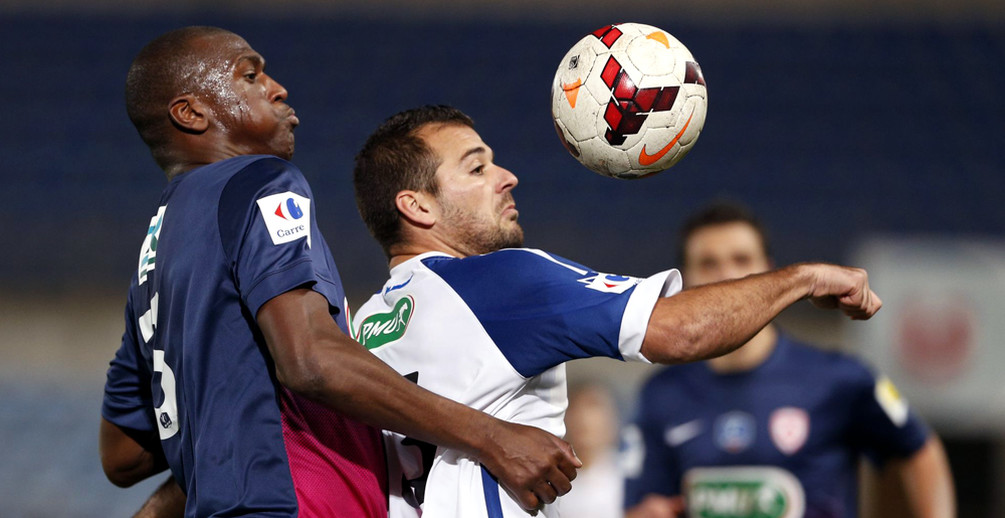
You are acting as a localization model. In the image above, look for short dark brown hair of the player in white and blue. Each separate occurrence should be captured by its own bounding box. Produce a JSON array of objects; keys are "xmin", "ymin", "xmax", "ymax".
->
[{"xmin": 353, "ymin": 105, "xmax": 474, "ymax": 256}]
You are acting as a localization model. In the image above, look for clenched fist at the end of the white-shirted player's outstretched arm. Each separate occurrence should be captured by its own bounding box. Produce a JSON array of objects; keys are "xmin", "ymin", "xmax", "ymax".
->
[{"xmin": 805, "ymin": 264, "xmax": 882, "ymax": 320}]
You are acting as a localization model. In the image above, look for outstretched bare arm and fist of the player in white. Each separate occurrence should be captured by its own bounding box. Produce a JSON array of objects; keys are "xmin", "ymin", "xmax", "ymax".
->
[{"xmin": 642, "ymin": 264, "xmax": 882, "ymax": 363}]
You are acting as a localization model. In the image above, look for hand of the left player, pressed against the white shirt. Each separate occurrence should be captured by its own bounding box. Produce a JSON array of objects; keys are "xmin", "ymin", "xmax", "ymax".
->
[{"xmin": 478, "ymin": 420, "xmax": 583, "ymax": 510}]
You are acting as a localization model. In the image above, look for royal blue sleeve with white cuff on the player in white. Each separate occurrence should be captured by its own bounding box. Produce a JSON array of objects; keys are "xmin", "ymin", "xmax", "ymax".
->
[{"xmin": 423, "ymin": 248, "xmax": 679, "ymax": 377}]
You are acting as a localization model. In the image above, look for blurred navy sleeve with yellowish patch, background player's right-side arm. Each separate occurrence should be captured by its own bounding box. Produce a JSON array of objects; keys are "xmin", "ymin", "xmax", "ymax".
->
[{"xmin": 850, "ymin": 362, "xmax": 929, "ymax": 466}]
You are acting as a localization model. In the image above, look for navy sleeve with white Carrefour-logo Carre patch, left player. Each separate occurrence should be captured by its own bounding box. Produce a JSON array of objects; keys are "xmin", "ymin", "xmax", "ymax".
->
[{"xmin": 218, "ymin": 157, "xmax": 342, "ymax": 315}]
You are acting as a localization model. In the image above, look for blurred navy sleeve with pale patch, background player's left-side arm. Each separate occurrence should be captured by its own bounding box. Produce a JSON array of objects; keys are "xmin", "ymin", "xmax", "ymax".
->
[{"xmin": 624, "ymin": 376, "xmax": 681, "ymax": 509}]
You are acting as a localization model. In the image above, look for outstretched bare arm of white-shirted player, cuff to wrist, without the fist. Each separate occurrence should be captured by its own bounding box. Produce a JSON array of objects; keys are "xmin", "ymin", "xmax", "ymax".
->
[{"xmin": 642, "ymin": 265, "xmax": 813, "ymax": 363}]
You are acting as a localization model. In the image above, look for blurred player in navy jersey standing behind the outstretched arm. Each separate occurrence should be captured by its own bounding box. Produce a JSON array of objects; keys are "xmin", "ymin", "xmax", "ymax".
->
[{"xmin": 626, "ymin": 203, "xmax": 955, "ymax": 518}]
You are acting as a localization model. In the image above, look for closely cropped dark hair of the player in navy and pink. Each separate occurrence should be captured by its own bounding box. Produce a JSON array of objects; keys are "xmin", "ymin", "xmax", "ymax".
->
[{"xmin": 126, "ymin": 26, "xmax": 230, "ymax": 167}]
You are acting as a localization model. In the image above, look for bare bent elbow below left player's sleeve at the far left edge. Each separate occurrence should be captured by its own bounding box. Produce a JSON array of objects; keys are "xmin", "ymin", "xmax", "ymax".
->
[{"xmin": 98, "ymin": 417, "xmax": 168, "ymax": 488}]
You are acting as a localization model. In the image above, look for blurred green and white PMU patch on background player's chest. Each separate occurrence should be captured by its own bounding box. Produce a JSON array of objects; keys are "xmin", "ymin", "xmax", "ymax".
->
[{"xmin": 683, "ymin": 466, "xmax": 806, "ymax": 518}]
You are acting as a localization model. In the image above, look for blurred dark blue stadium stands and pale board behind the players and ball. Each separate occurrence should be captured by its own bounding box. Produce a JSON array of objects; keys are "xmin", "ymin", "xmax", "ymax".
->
[{"xmin": 0, "ymin": 0, "xmax": 1005, "ymax": 517}]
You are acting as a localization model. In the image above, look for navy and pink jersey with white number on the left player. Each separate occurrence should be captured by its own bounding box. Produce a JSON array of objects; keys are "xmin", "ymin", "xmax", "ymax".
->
[{"xmin": 102, "ymin": 156, "xmax": 386, "ymax": 517}]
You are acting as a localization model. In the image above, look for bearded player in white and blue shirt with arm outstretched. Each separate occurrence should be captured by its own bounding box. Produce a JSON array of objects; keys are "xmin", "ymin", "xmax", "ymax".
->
[{"xmin": 354, "ymin": 107, "xmax": 880, "ymax": 518}]
